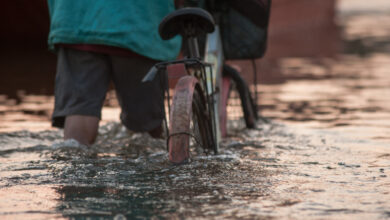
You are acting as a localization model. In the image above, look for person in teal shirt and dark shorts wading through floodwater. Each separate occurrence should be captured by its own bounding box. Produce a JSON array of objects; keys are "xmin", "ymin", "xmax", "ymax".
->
[{"xmin": 48, "ymin": 0, "xmax": 181, "ymax": 145}]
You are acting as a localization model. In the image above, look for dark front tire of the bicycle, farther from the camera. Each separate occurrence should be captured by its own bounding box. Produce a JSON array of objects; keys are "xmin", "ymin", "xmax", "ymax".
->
[{"xmin": 223, "ymin": 65, "xmax": 259, "ymax": 128}]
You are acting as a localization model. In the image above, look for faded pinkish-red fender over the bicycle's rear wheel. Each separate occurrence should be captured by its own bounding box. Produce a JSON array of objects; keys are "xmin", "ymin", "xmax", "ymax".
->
[{"xmin": 168, "ymin": 76, "xmax": 199, "ymax": 164}]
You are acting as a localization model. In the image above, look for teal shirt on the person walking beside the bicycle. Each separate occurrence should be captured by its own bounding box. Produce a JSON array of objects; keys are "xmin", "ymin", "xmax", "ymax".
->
[{"xmin": 48, "ymin": 0, "xmax": 181, "ymax": 60}]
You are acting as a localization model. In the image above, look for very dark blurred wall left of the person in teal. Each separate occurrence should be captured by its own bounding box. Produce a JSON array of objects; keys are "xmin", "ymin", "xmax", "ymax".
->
[{"xmin": 0, "ymin": 0, "xmax": 56, "ymax": 98}]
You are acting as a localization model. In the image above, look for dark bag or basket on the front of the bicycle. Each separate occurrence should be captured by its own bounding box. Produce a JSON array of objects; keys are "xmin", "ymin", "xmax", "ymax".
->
[{"xmin": 220, "ymin": 0, "xmax": 271, "ymax": 59}]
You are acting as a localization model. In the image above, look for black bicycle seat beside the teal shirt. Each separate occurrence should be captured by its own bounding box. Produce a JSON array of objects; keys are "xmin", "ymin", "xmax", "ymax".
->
[{"xmin": 158, "ymin": 8, "xmax": 215, "ymax": 40}]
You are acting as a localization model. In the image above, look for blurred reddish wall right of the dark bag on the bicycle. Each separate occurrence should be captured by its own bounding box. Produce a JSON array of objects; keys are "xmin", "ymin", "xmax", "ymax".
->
[{"xmin": 267, "ymin": 0, "xmax": 341, "ymax": 58}]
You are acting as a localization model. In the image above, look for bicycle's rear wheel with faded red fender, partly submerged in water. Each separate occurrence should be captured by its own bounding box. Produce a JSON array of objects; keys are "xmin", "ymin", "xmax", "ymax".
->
[{"xmin": 168, "ymin": 77, "xmax": 217, "ymax": 164}]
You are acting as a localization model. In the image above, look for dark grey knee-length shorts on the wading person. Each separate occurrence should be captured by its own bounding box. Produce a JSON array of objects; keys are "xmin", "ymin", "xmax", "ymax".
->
[{"xmin": 52, "ymin": 48, "xmax": 164, "ymax": 131}]
